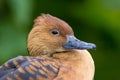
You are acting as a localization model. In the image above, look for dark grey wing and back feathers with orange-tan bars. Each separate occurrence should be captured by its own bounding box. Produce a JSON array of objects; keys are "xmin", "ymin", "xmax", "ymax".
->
[{"xmin": 0, "ymin": 56, "xmax": 60, "ymax": 80}]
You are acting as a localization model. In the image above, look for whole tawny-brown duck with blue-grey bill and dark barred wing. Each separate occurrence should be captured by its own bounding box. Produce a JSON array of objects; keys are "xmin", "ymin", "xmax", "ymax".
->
[{"xmin": 0, "ymin": 14, "xmax": 96, "ymax": 80}]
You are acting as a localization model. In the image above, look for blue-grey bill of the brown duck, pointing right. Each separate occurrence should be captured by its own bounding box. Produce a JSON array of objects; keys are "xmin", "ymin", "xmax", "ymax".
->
[{"xmin": 63, "ymin": 35, "xmax": 96, "ymax": 50}]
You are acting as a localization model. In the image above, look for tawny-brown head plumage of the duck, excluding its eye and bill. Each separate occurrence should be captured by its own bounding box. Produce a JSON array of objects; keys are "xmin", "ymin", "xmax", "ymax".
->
[{"xmin": 28, "ymin": 14, "xmax": 74, "ymax": 56}]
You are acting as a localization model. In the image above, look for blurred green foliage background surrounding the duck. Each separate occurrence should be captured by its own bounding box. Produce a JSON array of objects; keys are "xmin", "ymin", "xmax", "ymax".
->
[{"xmin": 0, "ymin": 0, "xmax": 120, "ymax": 80}]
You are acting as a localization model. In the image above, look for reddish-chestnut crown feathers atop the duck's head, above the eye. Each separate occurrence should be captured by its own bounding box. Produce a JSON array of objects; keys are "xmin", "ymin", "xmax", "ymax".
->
[{"xmin": 34, "ymin": 14, "xmax": 73, "ymax": 35}]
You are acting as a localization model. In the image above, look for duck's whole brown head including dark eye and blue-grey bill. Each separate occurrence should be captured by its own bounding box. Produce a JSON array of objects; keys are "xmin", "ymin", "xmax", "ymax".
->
[{"xmin": 27, "ymin": 14, "xmax": 96, "ymax": 56}]
